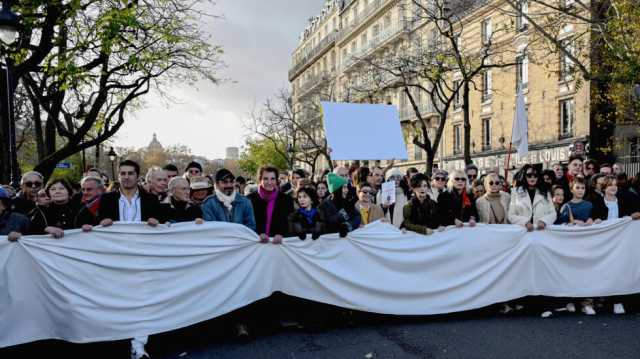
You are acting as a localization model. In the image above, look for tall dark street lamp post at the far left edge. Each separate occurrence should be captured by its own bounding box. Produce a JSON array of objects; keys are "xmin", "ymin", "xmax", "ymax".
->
[{"xmin": 0, "ymin": 0, "xmax": 20, "ymax": 188}]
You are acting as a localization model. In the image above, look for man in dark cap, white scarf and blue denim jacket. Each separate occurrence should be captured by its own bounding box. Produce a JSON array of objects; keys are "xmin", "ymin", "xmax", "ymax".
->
[{"xmin": 202, "ymin": 168, "xmax": 256, "ymax": 231}]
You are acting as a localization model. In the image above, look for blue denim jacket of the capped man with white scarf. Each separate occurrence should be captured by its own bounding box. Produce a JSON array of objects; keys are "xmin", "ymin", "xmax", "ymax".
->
[{"xmin": 202, "ymin": 194, "xmax": 256, "ymax": 231}]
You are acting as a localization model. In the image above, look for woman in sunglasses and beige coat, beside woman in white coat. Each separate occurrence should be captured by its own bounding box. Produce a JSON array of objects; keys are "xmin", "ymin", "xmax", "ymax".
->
[{"xmin": 476, "ymin": 173, "xmax": 511, "ymax": 224}]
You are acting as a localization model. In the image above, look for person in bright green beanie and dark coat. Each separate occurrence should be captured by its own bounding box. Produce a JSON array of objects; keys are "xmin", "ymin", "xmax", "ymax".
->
[{"xmin": 320, "ymin": 173, "xmax": 361, "ymax": 238}]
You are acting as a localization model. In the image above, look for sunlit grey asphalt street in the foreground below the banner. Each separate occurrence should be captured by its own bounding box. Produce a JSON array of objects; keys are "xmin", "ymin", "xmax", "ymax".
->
[{"xmin": 151, "ymin": 312, "xmax": 640, "ymax": 359}]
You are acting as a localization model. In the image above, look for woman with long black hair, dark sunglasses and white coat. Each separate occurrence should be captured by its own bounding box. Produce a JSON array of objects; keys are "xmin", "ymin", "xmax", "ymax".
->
[{"xmin": 508, "ymin": 164, "xmax": 556, "ymax": 232}]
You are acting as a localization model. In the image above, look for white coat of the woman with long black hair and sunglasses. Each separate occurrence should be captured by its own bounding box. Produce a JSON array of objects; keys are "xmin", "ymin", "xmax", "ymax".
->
[{"xmin": 509, "ymin": 188, "xmax": 556, "ymax": 226}]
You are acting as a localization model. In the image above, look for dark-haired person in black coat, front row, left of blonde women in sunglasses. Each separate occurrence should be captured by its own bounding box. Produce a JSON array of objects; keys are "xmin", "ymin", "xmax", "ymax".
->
[{"xmin": 402, "ymin": 173, "xmax": 438, "ymax": 235}]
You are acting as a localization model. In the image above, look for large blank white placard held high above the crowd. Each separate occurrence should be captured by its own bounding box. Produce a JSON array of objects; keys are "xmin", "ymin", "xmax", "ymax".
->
[{"xmin": 321, "ymin": 102, "xmax": 409, "ymax": 160}]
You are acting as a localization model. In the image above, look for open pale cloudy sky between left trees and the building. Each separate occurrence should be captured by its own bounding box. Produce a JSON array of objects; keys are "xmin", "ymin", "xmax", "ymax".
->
[{"xmin": 115, "ymin": 0, "xmax": 324, "ymax": 159}]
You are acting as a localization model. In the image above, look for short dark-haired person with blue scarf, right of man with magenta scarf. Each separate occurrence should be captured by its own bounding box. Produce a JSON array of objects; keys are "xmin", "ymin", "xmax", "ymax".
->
[{"xmin": 289, "ymin": 187, "xmax": 324, "ymax": 241}]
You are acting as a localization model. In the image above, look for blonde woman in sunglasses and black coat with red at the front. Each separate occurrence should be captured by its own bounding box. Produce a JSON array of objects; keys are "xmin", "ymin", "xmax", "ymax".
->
[{"xmin": 436, "ymin": 170, "xmax": 478, "ymax": 227}]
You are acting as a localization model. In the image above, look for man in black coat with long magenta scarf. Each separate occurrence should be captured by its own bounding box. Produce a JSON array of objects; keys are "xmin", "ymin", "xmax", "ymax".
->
[{"xmin": 249, "ymin": 166, "xmax": 294, "ymax": 244}]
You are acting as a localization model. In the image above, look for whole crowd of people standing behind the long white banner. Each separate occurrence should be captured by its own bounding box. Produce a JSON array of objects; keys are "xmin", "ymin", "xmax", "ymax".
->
[{"xmin": 0, "ymin": 156, "xmax": 640, "ymax": 344}]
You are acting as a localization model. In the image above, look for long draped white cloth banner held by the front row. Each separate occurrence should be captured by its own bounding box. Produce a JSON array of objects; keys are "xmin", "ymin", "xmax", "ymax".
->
[{"xmin": 0, "ymin": 219, "xmax": 640, "ymax": 347}]
